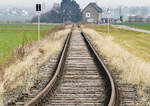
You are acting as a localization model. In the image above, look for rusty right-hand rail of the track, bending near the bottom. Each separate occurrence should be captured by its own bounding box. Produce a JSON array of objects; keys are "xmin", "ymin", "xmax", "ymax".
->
[{"xmin": 81, "ymin": 32, "xmax": 119, "ymax": 106}]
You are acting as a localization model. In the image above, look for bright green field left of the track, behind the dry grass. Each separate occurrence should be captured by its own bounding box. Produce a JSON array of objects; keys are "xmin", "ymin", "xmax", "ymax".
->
[{"xmin": 0, "ymin": 24, "xmax": 56, "ymax": 64}]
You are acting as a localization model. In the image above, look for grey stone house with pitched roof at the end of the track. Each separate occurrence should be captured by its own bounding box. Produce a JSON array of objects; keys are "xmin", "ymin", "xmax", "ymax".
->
[{"xmin": 82, "ymin": 3, "xmax": 102, "ymax": 24}]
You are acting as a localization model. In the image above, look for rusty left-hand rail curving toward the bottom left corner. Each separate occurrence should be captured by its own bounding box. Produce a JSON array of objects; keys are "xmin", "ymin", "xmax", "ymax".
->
[{"xmin": 25, "ymin": 31, "xmax": 72, "ymax": 106}]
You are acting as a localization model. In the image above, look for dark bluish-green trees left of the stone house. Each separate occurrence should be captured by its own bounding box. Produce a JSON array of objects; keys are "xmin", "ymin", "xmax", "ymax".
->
[{"xmin": 32, "ymin": 0, "xmax": 82, "ymax": 23}]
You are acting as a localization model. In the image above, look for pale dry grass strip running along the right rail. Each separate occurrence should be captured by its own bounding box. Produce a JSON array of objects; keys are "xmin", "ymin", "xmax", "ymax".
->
[{"xmin": 83, "ymin": 29, "xmax": 150, "ymax": 86}]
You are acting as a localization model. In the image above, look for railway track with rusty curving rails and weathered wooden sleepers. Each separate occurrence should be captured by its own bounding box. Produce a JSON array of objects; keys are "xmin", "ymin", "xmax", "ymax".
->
[{"xmin": 7, "ymin": 27, "xmax": 119, "ymax": 106}]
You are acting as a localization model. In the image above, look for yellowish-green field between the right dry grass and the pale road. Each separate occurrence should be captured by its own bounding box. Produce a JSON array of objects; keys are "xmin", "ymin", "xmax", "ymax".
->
[{"xmin": 88, "ymin": 25, "xmax": 150, "ymax": 62}]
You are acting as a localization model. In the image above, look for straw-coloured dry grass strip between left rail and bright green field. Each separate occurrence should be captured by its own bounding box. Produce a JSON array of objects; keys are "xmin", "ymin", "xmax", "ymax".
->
[{"xmin": 0, "ymin": 27, "xmax": 70, "ymax": 105}]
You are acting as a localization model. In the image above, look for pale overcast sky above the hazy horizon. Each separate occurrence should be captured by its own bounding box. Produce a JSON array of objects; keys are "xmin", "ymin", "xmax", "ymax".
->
[{"xmin": 0, "ymin": 0, "xmax": 150, "ymax": 8}]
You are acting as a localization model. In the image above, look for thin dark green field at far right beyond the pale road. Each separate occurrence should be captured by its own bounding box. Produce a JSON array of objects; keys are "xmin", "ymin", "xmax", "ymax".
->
[{"xmin": 118, "ymin": 22, "xmax": 150, "ymax": 30}]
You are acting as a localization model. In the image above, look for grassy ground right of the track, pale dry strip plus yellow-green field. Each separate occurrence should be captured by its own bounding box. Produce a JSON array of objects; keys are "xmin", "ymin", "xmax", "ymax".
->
[{"xmin": 83, "ymin": 25, "xmax": 150, "ymax": 106}]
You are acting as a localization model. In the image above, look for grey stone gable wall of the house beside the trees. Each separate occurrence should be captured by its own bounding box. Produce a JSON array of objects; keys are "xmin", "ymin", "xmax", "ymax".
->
[{"xmin": 82, "ymin": 5, "xmax": 102, "ymax": 24}]
